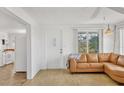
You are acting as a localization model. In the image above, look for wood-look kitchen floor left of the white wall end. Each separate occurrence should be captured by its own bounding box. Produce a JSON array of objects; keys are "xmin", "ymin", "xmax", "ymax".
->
[{"xmin": 0, "ymin": 64, "xmax": 26, "ymax": 86}]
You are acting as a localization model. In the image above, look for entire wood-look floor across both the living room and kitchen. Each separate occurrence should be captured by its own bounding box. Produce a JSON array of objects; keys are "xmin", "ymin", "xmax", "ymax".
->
[{"xmin": 0, "ymin": 64, "xmax": 123, "ymax": 86}]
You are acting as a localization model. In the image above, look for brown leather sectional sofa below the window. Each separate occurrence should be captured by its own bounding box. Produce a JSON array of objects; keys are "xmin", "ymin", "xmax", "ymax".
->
[{"xmin": 69, "ymin": 53, "xmax": 124, "ymax": 83}]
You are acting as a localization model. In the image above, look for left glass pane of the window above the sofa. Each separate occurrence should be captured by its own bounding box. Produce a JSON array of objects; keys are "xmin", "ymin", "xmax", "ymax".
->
[{"xmin": 78, "ymin": 32, "xmax": 87, "ymax": 53}]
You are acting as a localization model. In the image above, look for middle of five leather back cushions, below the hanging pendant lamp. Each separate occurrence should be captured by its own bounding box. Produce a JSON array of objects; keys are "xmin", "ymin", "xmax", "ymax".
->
[{"xmin": 98, "ymin": 53, "xmax": 111, "ymax": 62}]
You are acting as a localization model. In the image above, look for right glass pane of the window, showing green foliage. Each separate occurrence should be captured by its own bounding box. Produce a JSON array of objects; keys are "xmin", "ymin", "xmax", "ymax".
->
[{"xmin": 88, "ymin": 32, "xmax": 99, "ymax": 53}]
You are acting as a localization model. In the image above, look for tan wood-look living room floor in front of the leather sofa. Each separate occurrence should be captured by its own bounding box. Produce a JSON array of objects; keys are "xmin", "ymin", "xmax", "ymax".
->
[{"xmin": 24, "ymin": 70, "xmax": 123, "ymax": 86}]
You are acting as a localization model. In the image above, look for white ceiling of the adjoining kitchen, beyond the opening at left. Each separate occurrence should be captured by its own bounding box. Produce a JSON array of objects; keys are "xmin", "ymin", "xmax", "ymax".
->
[{"xmin": 0, "ymin": 10, "xmax": 25, "ymax": 33}]
